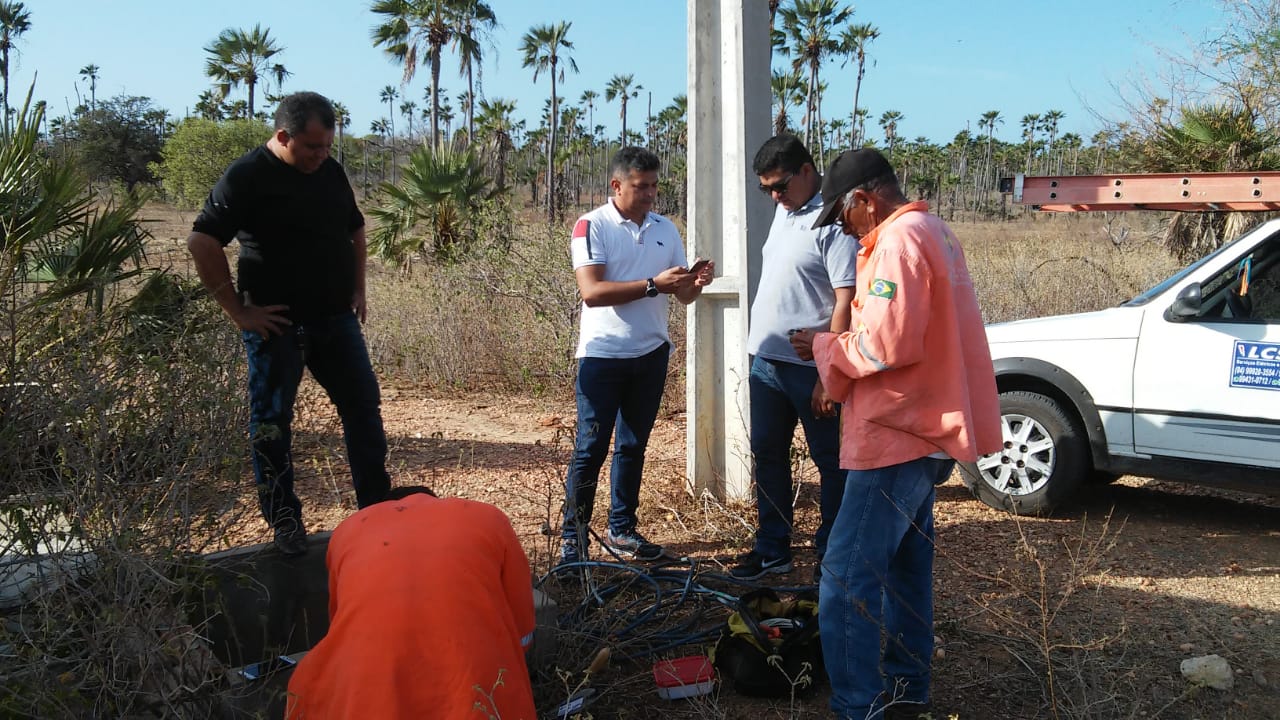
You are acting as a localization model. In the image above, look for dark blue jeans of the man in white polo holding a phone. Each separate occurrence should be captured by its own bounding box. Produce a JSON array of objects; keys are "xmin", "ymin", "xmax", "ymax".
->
[{"xmin": 561, "ymin": 342, "xmax": 671, "ymax": 548}]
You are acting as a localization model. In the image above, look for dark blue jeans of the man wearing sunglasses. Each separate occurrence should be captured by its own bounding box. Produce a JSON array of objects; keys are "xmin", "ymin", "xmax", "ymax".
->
[{"xmin": 749, "ymin": 357, "xmax": 845, "ymax": 561}]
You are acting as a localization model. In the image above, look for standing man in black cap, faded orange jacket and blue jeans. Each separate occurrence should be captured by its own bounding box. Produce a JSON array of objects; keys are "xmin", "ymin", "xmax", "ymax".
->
[{"xmin": 792, "ymin": 149, "xmax": 1001, "ymax": 720}]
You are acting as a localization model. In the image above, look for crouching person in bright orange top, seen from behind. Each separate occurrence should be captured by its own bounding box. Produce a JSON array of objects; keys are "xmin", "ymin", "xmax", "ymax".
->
[{"xmin": 284, "ymin": 488, "xmax": 538, "ymax": 720}]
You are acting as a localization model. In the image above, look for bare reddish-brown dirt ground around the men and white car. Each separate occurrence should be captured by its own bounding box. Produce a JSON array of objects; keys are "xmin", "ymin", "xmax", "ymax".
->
[{"xmin": 244, "ymin": 389, "xmax": 1280, "ymax": 720}]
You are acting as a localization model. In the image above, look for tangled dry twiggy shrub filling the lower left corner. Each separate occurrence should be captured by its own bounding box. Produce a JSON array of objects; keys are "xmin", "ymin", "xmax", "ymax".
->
[{"xmin": 0, "ymin": 295, "xmax": 247, "ymax": 717}]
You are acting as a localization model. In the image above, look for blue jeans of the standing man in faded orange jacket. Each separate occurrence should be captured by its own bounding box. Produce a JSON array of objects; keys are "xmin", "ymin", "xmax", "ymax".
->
[{"xmin": 818, "ymin": 457, "xmax": 955, "ymax": 720}]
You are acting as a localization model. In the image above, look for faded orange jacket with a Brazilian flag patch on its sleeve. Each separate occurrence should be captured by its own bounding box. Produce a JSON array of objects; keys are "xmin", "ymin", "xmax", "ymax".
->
[{"xmin": 813, "ymin": 202, "xmax": 1002, "ymax": 470}]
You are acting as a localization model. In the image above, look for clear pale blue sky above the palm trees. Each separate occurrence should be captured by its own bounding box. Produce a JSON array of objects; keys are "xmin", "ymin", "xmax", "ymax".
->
[{"xmin": 10, "ymin": 0, "xmax": 1225, "ymax": 142}]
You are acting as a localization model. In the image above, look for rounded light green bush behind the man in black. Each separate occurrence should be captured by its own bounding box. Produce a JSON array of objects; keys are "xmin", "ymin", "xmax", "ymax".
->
[{"xmin": 159, "ymin": 118, "xmax": 271, "ymax": 208}]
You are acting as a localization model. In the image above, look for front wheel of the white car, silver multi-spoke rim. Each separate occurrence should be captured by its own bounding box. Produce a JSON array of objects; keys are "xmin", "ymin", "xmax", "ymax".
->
[{"xmin": 960, "ymin": 391, "xmax": 1091, "ymax": 515}]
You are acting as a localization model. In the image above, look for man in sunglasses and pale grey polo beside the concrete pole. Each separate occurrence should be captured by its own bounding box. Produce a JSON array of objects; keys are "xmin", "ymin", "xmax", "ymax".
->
[{"xmin": 730, "ymin": 135, "xmax": 858, "ymax": 582}]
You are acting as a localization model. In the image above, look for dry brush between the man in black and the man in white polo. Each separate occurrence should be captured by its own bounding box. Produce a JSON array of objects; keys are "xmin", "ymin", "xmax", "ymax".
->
[{"xmin": 366, "ymin": 224, "xmax": 579, "ymax": 395}]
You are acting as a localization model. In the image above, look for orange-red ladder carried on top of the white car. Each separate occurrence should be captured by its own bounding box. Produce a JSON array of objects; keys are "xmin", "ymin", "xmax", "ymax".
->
[{"xmin": 1000, "ymin": 172, "xmax": 1280, "ymax": 213}]
